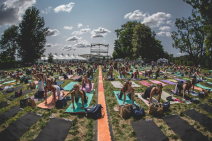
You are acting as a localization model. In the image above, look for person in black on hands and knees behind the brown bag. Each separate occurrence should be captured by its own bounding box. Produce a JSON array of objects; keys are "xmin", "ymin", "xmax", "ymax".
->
[{"xmin": 140, "ymin": 83, "xmax": 163, "ymax": 103}]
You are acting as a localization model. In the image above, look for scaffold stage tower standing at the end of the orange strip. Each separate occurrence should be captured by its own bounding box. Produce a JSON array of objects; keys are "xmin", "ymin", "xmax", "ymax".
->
[{"xmin": 90, "ymin": 44, "xmax": 109, "ymax": 59}]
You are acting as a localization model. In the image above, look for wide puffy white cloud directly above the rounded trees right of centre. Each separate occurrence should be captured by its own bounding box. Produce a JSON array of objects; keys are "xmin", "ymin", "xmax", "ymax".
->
[{"xmin": 124, "ymin": 10, "xmax": 171, "ymax": 27}]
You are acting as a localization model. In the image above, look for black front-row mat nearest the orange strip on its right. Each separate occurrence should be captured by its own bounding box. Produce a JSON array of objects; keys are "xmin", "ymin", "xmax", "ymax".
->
[{"xmin": 131, "ymin": 120, "xmax": 169, "ymax": 141}]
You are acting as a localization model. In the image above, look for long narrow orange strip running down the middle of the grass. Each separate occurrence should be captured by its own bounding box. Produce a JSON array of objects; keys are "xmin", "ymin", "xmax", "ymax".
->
[{"xmin": 97, "ymin": 66, "xmax": 111, "ymax": 141}]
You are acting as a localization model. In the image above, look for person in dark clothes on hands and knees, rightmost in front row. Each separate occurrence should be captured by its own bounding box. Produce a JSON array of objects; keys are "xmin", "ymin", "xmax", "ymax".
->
[{"xmin": 171, "ymin": 80, "xmax": 191, "ymax": 101}]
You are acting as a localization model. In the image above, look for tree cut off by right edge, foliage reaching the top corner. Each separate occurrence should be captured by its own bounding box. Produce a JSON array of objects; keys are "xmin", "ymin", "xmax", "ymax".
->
[{"xmin": 183, "ymin": 0, "xmax": 212, "ymax": 57}]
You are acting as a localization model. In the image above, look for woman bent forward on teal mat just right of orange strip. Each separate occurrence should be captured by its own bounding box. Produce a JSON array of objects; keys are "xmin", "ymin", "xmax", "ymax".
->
[{"xmin": 117, "ymin": 81, "xmax": 135, "ymax": 104}]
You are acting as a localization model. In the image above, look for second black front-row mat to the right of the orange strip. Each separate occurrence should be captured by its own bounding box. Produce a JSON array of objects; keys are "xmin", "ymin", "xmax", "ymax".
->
[{"xmin": 163, "ymin": 115, "xmax": 208, "ymax": 141}]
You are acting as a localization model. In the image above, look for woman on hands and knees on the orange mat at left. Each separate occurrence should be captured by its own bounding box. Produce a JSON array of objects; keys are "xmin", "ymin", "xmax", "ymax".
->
[{"xmin": 44, "ymin": 78, "xmax": 65, "ymax": 105}]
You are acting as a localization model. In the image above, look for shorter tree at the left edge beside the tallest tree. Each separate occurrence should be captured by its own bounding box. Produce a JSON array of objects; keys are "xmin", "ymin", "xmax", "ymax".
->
[{"xmin": 0, "ymin": 25, "xmax": 18, "ymax": 61}]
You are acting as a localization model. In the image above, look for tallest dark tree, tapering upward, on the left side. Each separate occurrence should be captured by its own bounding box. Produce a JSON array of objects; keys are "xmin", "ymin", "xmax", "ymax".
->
[{"xmin": 18, "ymin": 7, "xmax": 48, "ymax": 62}]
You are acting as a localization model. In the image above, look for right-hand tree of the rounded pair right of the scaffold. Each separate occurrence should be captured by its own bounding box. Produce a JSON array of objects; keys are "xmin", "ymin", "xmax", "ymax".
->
[{"xmin": 132, "ymin": 23, "xmax": 164, "ymax": 60}]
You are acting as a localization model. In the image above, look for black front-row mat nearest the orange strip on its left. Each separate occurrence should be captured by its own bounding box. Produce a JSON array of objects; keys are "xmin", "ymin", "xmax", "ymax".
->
[{"xmin": 35, "ymin": 118, "xmax": 72, "ymax": 141}]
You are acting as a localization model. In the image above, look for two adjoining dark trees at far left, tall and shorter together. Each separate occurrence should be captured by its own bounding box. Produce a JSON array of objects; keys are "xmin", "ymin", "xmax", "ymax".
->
[{"xmin": 0, "ymin": 7, "xmax": 48, "ymax": 66}]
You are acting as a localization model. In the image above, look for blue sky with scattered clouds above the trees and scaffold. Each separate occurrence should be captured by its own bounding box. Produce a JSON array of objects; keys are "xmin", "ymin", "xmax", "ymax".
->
[{"xmin": 0, "ymin": 0, "xmax": 192, "ymax": 56}]
